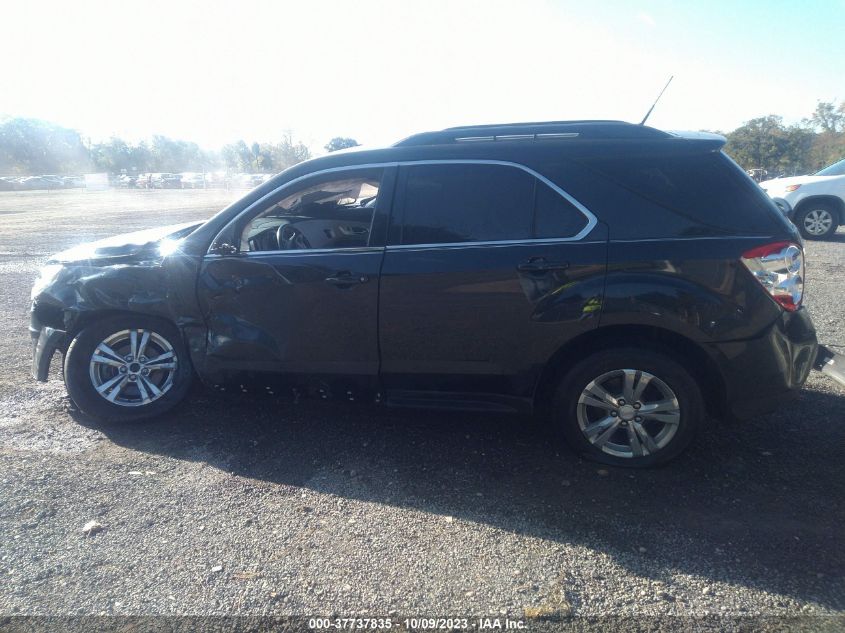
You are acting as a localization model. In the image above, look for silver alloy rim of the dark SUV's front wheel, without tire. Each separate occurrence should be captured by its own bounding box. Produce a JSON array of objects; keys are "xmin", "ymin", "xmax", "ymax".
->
[{"xmin": 89, "ymin": 329, "xmax": 179, "ymax": 407}]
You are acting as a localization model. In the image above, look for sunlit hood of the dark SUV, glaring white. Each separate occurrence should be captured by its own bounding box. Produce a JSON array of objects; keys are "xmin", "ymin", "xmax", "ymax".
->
[{"xmin": 47, "ymin": 221, "xmax": 204, "ymax": 264}]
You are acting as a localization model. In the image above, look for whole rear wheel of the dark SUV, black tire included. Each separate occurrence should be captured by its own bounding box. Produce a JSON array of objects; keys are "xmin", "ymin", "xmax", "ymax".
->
[{"xmin": 553, "ymin": 347, "xmax": 705, "ymax": 468}]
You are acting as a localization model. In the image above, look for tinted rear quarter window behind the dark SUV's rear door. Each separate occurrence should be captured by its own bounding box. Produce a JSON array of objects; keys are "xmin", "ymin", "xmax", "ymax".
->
[{"xmin": 583, "ymin": 152, "xmax": 778, "ymax": 234}]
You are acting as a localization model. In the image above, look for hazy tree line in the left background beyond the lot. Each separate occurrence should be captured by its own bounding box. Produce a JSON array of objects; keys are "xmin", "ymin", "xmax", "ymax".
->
[{"xmin": 0, "ymin": 118, "xmax": 358, "ymax": 176}]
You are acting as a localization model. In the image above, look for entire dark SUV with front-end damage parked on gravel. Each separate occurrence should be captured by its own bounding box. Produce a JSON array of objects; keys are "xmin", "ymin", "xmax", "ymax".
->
[{"xmin": 30, "ymin": 121, "xmax": 823, "ymax": 466}]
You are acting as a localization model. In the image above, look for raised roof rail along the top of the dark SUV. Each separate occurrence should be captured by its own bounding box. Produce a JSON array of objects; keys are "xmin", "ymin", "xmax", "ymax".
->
[{"xmin": 393, "ymin": 121, "xmax": 669, "ymax": 147}]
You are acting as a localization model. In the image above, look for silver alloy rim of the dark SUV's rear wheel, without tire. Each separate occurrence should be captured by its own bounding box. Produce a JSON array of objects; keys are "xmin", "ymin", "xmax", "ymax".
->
[{"xmin": 577, "ymin": 369, "xmax": 681, "ymax": 458}]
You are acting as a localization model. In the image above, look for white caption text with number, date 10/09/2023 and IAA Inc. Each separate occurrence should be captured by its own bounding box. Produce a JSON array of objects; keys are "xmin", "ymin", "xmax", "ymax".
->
[{"xmin": 308, "ymin": 617, "xmax": 528, "ymax": 631}]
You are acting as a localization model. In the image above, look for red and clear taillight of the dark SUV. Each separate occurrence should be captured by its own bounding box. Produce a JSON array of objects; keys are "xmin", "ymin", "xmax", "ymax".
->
[{"xmin": 742, "ymin": 242, "xmax": 804, "ymax": 312}]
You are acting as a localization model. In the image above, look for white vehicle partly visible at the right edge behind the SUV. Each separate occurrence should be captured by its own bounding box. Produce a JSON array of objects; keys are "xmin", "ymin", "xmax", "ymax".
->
[{"xmin": 760, "ymin": 159, "xmax": 845, "ymax": 240}]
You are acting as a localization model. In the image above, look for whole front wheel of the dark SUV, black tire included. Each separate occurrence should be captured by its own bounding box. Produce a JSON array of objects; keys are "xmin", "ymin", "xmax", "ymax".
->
[{"xmin": 64, "ymin": 315, "xmax": 192, "ymax": 422}]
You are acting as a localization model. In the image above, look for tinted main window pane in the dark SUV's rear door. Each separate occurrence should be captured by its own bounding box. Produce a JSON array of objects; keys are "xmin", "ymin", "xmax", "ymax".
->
[{"xmin": 402, "ymin": 164, "xmax": 535, "ymax": 244}]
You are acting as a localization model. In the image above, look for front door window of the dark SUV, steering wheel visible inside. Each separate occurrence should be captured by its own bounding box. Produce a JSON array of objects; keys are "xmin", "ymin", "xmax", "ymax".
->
[{"xmin": 240, "ymin": 169, "xmax": 384, "ymax": 252}]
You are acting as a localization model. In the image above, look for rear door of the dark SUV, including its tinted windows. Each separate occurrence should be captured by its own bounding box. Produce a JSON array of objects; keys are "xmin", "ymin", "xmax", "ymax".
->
[{"xmin": 379, "ymin": 161, "xmax": 607, "ymax": 398}]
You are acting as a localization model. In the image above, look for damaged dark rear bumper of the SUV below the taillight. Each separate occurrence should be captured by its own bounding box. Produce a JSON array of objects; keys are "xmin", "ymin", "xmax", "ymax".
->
[{"xmin": 713, "ymin": 308, "xmax": 818, "ymax": 419}]
